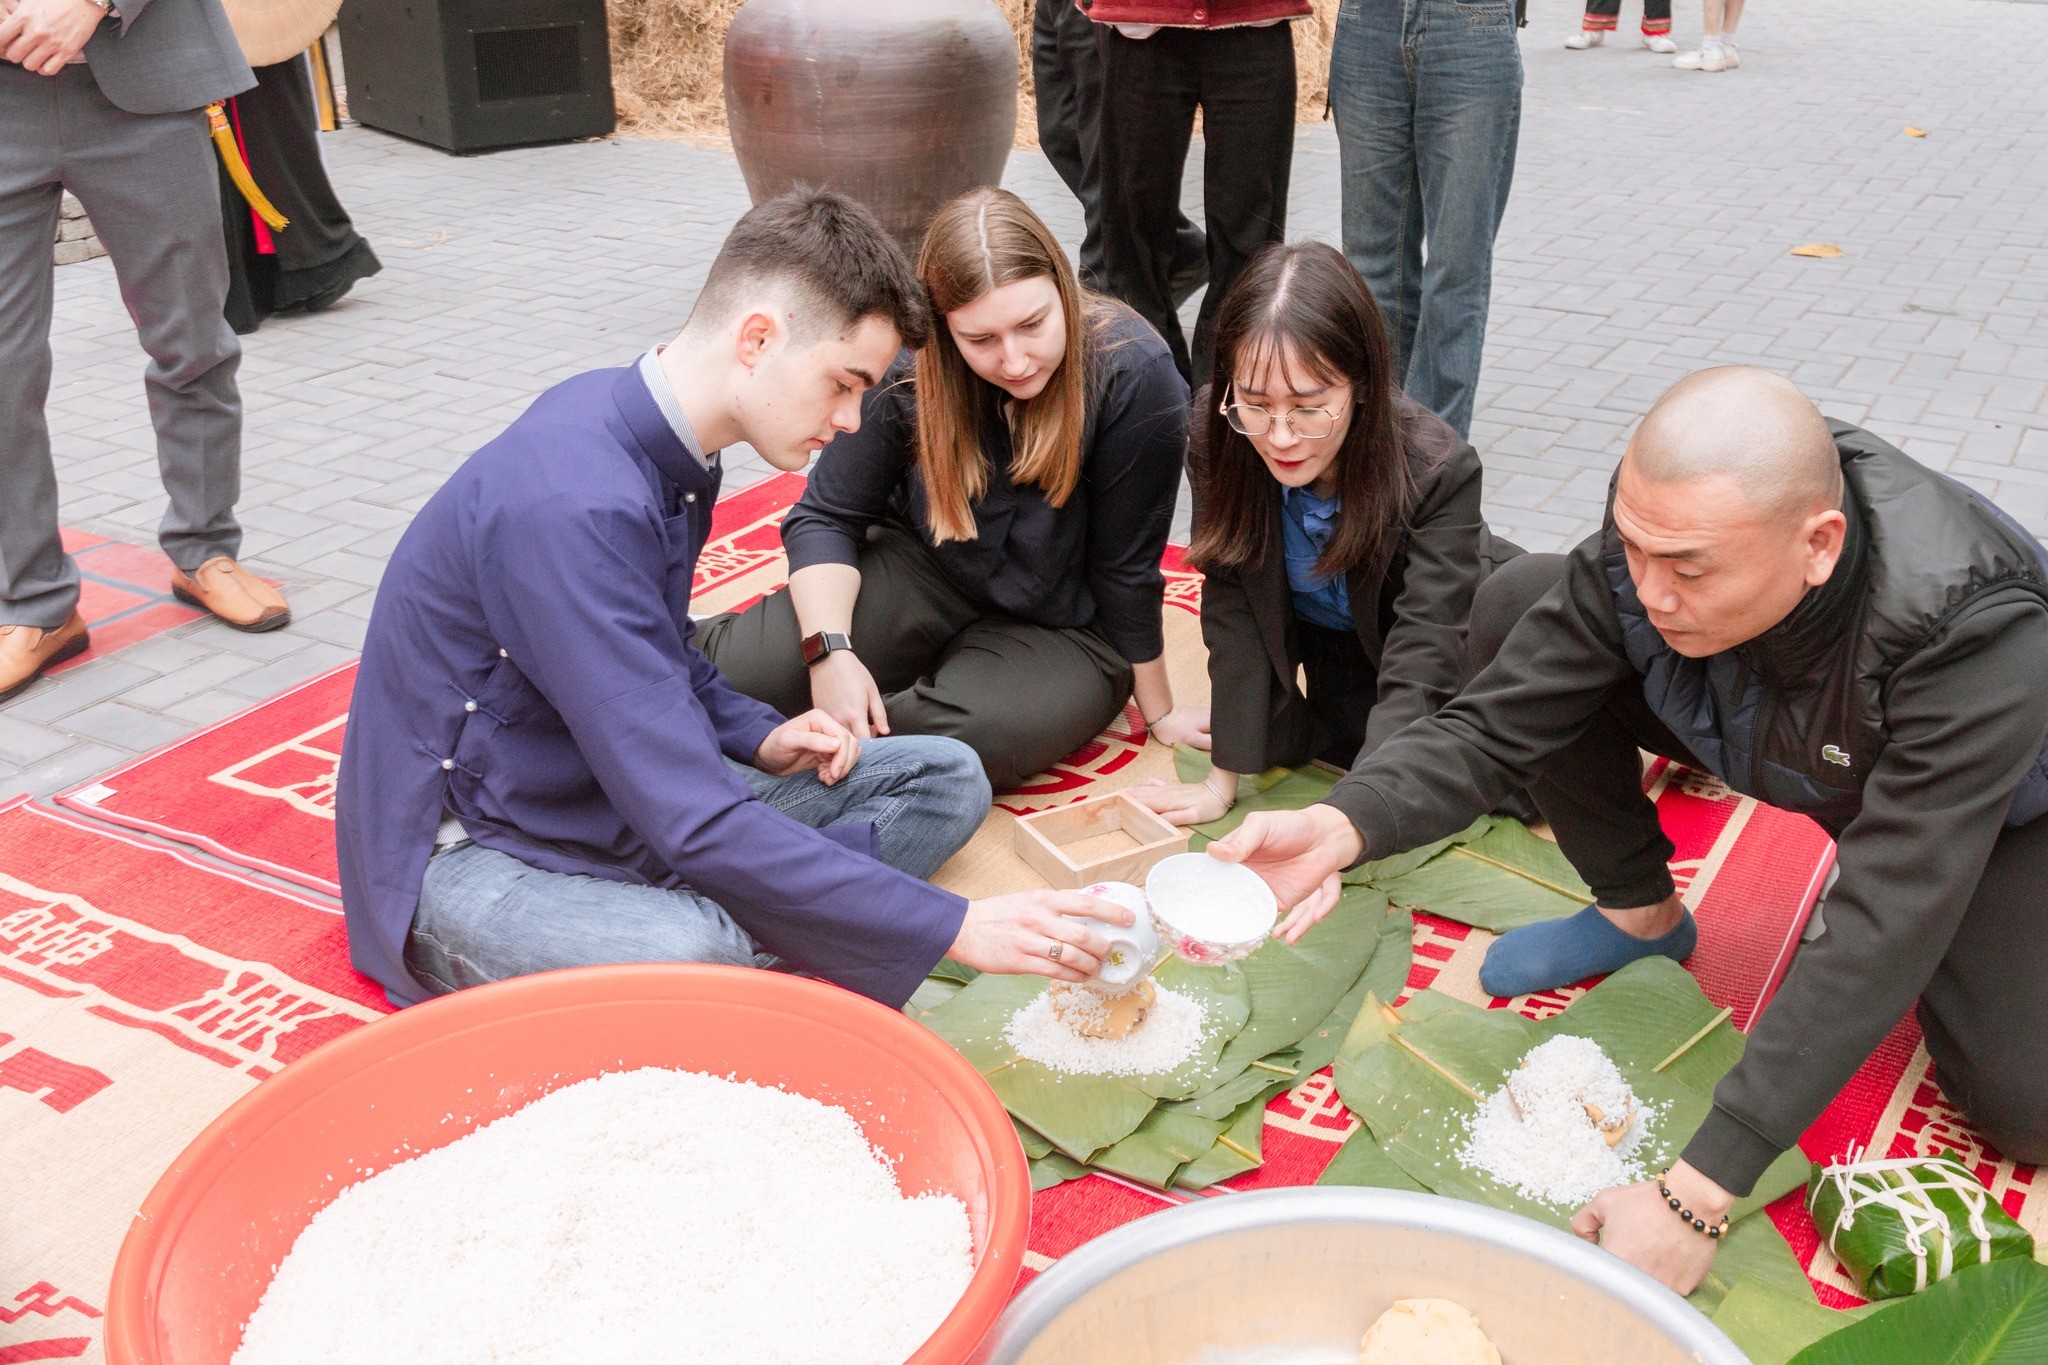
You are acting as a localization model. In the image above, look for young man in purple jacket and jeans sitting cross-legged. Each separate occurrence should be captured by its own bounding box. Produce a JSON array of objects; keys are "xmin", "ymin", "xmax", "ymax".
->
[{"xmin": 336, "ymin": 192, "xmax": 1128, "ymax": 1005}]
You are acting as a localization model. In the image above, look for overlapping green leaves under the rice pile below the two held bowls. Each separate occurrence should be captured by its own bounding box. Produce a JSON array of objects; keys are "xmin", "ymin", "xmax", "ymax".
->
[{"xmin": 907, "ymin": 886, "xmax": 1413, "ymax": 1189}]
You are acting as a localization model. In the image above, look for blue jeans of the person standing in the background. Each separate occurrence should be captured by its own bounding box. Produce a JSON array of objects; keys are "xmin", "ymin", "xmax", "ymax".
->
[{"xmin": 1329, "ymin": 0, "xmax": 1522, "ymax": 436}]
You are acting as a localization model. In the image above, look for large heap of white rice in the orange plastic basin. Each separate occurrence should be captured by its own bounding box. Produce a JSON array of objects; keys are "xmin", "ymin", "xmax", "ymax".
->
[{"xmin": 233, "ymin": 1068, "xmax": 973, "ymax": 1365}]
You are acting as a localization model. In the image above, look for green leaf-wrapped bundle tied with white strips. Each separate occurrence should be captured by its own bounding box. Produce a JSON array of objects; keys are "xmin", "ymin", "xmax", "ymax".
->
[{"xmin": 1806, "ymin": 1152, "xmax": 2034, "ymax": 1300}]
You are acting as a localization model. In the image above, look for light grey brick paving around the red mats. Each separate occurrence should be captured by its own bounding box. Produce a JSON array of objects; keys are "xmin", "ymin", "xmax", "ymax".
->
[{"xmin": 0, "ymin": 0, "xmax": 2048, "ymax": 798}]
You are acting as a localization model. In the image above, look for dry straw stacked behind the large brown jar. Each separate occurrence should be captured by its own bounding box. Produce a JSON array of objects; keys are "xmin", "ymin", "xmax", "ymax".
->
[{"xmin": 606, "ymin": 0, "xmax": 1337, "ymax": 147}]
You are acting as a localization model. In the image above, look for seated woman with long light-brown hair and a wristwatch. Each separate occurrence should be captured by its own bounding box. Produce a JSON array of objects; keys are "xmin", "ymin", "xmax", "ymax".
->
[{"xmin": 700, "ymin": 188, "xmax": 1198, "ymax": 790}]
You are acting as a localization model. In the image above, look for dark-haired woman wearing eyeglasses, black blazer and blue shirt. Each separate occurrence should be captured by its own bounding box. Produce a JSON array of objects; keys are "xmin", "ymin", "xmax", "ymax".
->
[{"xmin": 1133, "ymin": 241, "xmax": 1520, "ymax": 825}]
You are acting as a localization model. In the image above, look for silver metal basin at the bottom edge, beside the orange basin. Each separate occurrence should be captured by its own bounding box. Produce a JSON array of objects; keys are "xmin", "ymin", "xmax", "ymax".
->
[{"xmin": 973, "ymin": 1189, "xmax": 1747, "ymax": 1365}]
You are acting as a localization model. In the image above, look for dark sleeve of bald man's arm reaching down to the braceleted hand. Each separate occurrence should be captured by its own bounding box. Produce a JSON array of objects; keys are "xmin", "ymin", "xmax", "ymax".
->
[{"xmin": 1686, "ymin": 598, "xmax": 2048, "ymax": 1195}]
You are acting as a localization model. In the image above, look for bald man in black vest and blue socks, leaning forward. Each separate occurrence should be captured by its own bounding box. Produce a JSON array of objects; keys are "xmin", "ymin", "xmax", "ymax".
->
[{"xmin": 1212, "ymin": 366, "xmax": 2048, "ymax": 1293}]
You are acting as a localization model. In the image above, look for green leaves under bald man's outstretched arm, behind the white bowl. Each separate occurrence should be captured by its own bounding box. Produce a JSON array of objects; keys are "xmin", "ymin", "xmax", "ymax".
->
[{"xmin": 1174, "ymin": 749, "xmax": 1593, "ymax": 933}]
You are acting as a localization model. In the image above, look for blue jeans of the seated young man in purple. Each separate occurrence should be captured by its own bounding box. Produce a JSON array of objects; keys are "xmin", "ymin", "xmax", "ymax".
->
[{"xmin": 406, "ymin": 735, "xmax": 989, "ymax": 995}]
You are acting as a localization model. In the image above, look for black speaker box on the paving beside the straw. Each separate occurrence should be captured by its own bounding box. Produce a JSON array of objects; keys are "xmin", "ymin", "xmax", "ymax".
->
[{"xmin": 342, "ymin": 0, "xmax": 618, "ymax": 153}]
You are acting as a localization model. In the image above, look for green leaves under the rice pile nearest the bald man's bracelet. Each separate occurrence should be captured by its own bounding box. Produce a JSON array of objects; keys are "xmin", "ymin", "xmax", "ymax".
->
[{"xmin": 1323, "ymin": 958, "xmax": 1812, "ymax": 1308}]
